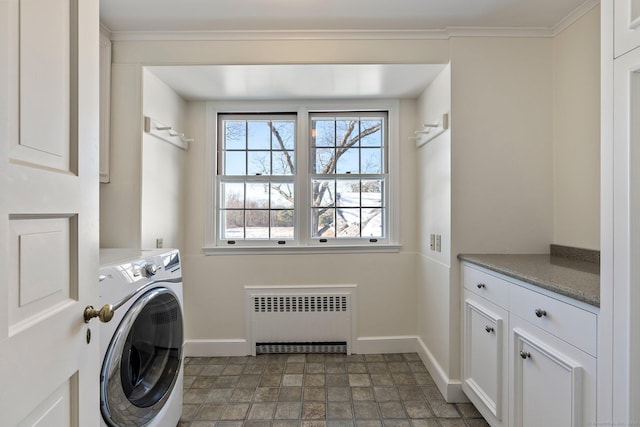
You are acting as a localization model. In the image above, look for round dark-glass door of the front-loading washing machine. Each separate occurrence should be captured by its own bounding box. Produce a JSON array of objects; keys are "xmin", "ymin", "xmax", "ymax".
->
[{"xmin": 100, "ymin": 288, "xmax": 183, "ymax": 427}]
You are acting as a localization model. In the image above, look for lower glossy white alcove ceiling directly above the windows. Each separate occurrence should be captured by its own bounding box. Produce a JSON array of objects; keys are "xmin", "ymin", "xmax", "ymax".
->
[{"xmin": 148, "ymin": 64, "xmax": 444, "ymax": 100}]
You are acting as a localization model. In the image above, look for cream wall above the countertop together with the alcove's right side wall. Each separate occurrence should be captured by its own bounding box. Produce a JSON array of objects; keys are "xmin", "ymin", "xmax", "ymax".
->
[{"xmin": 417, "ymin": 37, "xmax": 553, "ymax": 401}]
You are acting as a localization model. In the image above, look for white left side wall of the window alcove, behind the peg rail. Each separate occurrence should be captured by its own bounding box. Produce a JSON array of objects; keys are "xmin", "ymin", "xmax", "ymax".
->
[{"xmin": 141, "ymin": 69, "xmax": 188, "ymax": 249}]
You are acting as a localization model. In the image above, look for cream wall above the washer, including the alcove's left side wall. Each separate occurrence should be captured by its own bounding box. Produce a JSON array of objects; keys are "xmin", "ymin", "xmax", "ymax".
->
[{"xmin": 100, "ymin": 64, "xmax": 186, "ymax": 249}]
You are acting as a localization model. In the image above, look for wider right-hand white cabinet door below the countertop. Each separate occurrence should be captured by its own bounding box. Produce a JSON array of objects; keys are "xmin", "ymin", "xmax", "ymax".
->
[{"xmin": 510, "ymin": 316, "xmax": 596, "ymax": 427}]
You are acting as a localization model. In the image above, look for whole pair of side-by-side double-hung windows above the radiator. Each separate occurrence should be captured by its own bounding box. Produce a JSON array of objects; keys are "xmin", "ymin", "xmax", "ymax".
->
[{"xmin": 212, "ymin": 102, "xmax": 395, "ymax": 249}]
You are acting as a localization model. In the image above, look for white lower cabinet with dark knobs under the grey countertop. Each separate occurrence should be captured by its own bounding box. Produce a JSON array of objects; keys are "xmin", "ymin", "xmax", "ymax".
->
[{"xmin": 462, "ymin": 264, "xmax": 597, "ymax": 427}]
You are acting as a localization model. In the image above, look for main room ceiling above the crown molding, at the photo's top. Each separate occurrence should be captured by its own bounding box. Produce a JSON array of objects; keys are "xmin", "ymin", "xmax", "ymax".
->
[{"xmin": 100, "ymin": 0, "xmax": 585, "ymax": 32}]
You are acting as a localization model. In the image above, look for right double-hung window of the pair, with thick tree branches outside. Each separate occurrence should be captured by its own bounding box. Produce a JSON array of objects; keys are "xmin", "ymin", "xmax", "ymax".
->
[{"xmin": 309, "ymin": 112, "xmax": 387, "ymax": 243}]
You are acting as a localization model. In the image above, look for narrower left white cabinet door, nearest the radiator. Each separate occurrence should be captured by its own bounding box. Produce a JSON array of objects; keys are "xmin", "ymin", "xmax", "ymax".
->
[{"xmin": 462, "ymin": 291, "xmax": 507, "ymax": 426}]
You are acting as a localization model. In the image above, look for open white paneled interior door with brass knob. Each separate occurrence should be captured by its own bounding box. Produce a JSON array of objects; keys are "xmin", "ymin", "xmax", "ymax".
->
[{"xmin": 0, "ymin": 0, "xmax": 100, "ymax": 427}]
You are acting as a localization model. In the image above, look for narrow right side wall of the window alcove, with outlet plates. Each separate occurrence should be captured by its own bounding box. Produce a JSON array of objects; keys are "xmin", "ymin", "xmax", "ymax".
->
[{"xmin": 416, "ymin": 66, "xmax": 458, "ymax": 393}]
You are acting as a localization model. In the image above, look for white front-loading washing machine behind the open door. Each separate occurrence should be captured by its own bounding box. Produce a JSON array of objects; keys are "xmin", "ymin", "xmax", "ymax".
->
[{"xmin": 99, "ymin": 249, "xmax": 184, "ymax": 427}]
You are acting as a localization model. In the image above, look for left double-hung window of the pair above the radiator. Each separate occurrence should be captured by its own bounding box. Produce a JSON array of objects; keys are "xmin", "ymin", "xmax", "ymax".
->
[{"xmin": 218, "ymin": 114, "xmax": 296, "ymax": 244}]
